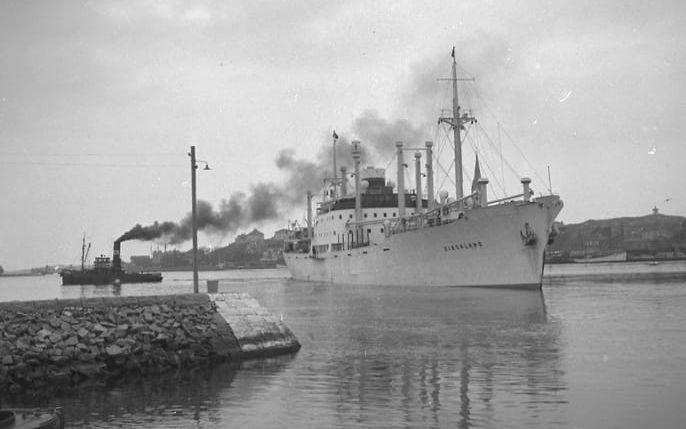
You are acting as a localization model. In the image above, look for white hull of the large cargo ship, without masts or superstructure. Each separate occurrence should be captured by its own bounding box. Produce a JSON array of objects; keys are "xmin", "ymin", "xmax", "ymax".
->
[{"xmin": 284, "ymin": 196, "xmax": 562, "ymax": 288}]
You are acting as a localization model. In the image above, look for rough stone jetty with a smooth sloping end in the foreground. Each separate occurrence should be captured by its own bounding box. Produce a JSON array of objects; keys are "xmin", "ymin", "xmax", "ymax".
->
[{"xmin": 0, "ymin": 294, "xmax": 300, "ymax": 391}]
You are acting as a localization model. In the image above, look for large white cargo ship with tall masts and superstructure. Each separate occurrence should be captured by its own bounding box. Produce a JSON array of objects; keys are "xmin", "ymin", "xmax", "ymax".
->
[{"xmin": 284, "ymin": 48, "xmax": 563, "ymax": 288}]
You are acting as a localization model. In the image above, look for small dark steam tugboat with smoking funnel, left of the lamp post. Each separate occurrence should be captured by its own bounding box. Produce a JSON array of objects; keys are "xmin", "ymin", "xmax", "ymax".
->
[{"xmin": 60, "ymin": 239, "xmax": 162, "ymax": 286}]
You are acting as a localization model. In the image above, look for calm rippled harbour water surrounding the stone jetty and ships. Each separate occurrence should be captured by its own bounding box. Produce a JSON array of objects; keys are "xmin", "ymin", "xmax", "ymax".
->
[{"xmin": 0, "ymin": 262, "xmax": 686, "ymax": 428}]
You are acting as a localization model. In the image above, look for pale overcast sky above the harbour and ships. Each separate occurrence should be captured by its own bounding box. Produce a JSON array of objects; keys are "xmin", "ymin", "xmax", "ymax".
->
[{"xmin": 0, "ymin": 0, "xmax": 686, "ymax": 269}]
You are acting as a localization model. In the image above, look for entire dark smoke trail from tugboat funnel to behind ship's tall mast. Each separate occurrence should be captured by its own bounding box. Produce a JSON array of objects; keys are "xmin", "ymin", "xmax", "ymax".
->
[{"xmin": 119, "ymin": 44, "xmax": 528, "ymax": 244}]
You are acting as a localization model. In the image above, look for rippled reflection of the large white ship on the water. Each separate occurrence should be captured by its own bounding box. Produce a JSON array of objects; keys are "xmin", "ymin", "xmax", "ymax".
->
[{"xmin": 318, "ymin": 289, "xmax": 566, "ymax": 428}]
